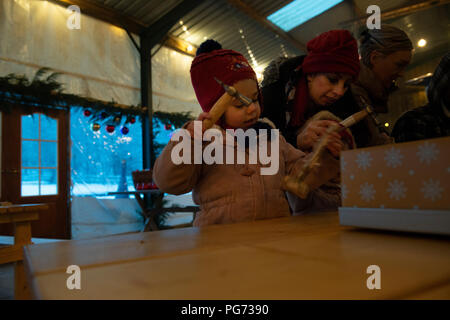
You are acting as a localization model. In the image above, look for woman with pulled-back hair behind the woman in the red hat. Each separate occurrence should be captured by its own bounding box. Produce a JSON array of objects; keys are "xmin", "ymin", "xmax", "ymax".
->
[{"xmin": 351, "ymin": 25, "xmax": 413, "ymax": 146}]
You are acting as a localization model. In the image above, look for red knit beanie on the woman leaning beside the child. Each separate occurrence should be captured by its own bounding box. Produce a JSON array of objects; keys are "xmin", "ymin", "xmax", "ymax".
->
[{"xmin": 302, "ymin": 30, "xmax": 359, "ymax": 78}]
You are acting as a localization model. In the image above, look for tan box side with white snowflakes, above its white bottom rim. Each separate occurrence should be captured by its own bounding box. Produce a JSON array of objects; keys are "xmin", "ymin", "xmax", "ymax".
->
[{"xmin": 341, "ymin": 137, "xmax": 450, "ymax": 211}]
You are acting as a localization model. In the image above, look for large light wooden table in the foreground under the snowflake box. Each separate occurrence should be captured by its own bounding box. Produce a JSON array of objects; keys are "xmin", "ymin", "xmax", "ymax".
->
[{"xmin": 25, "ymin": 212, "xmax": 450, "ymax": 299}]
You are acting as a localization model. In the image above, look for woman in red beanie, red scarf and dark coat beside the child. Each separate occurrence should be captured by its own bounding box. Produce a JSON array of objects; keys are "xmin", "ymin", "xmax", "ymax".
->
[{"xmin": 261, "ymin": 30, "xmax": 367, "ymax": 153}]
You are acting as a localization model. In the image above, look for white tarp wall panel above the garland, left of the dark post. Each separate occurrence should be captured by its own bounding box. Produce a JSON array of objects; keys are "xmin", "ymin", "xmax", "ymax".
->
[{"xmin": 0, "ymin": 0, "xmax": 140, "ymax": 105}]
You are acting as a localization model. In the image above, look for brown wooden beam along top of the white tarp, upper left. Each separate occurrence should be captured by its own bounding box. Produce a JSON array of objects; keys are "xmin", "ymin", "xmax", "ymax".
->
[{"xmin": 50, "ymin": 0, "xmax": 146, "ymax": 34}]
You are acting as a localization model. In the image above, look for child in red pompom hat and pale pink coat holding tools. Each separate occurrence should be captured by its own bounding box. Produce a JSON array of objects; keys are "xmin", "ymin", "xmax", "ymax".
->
[{"xmin": 153, "ymin": 40, "xmax": 344, "ymax": 226}]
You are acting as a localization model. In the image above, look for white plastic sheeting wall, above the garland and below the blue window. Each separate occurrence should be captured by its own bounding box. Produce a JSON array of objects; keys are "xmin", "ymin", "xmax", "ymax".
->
[{"xmin": 0, "ymin": 0, "xmax": 201, "ymax": 239}]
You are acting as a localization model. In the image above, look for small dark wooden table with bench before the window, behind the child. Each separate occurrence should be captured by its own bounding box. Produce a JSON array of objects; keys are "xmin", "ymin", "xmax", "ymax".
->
[{"xmin": 108, "ymin": 190, "xmax": 199, "ymax": 231}]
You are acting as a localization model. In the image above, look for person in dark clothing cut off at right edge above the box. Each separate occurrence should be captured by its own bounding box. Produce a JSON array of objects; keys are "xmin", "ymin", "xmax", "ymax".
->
[{"xmin": 391, "ymin": 52, "xmax": 450, "ymax": 142}]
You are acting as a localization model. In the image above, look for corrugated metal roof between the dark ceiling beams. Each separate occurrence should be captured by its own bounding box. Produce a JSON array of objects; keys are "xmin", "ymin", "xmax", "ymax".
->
[{"xmin": 75, "ymin": 0, "xmax": 450, "ymax": 71}]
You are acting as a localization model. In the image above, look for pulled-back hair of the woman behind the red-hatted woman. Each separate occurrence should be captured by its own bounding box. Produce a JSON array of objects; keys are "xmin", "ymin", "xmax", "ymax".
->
[{"xmin": 359, "ymin": 25, "xmax": 413, "ymax": 67}]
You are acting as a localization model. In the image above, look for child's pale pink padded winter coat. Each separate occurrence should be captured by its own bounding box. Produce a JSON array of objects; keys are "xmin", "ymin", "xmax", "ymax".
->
[{"xmin": 153, "ymin": 120, "xmax": 305, "ymax": 226}]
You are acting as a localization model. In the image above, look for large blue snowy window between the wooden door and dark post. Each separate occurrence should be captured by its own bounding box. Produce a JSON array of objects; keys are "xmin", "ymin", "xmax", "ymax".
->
[{"xmin": 70, "ymin": 108, "xmax": 142, "ymax": 196}]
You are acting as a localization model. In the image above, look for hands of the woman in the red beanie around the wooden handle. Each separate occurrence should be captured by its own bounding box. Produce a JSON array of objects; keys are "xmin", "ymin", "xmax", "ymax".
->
[{"xmin": 297, "ymin": 120, "xmax": 344, "ymax": 157}]
